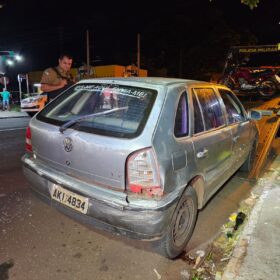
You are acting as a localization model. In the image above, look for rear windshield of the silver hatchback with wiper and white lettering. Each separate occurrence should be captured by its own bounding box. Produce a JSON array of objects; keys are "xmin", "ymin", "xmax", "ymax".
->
[{"xmin": 37, "ymin": 84, "xmax": 157, "ymax": 138}]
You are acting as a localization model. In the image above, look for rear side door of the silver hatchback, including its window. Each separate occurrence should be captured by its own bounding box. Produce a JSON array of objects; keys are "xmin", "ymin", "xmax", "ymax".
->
[{"xmin": 192, "ymin": 87, "xmax": 232, "ymax": 197}]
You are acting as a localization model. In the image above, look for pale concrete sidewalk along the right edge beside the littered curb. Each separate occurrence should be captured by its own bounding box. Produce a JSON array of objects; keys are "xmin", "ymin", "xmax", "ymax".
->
[{"xmin": 222, "ymin": 143, "xmax": 280, "ymax": 280}]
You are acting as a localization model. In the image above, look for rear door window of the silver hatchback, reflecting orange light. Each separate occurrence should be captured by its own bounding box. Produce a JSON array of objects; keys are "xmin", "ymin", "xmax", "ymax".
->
[{"xmin": 194, "ymin": 88, "xmax": 225, "ymax": 130}]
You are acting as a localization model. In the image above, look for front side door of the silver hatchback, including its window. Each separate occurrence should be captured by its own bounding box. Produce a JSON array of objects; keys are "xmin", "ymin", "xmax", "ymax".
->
[{"xmin": 219, "ymin": 88, "xmax": 251, "ymax": 169}]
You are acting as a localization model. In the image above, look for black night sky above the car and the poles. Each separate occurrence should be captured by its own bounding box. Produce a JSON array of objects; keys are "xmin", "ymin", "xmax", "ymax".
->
[{"xmin": 0, "ymin": 0, "xmax": 280, "ymax": 81}]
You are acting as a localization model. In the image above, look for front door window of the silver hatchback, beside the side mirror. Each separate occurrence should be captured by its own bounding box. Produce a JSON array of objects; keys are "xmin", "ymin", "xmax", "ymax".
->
[{"xmin": 219, "ymin": 89, "xmax": 245, "ymax": 124}]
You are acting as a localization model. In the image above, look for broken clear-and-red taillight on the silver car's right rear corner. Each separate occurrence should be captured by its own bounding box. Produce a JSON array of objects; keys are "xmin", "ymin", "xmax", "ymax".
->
[{"xmin": 127, "ymin": 148, "xmax": 163, "ymax": 196}]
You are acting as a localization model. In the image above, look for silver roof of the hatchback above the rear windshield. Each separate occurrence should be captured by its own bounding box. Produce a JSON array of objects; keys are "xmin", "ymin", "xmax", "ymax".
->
[{"xmin": 76, "ymin": 77, "xmax": 209, "ymax": 86}]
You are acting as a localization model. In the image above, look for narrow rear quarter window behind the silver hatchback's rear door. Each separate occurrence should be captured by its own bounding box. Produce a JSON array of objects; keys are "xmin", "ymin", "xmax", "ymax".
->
[{"xmin": 174, "ymin": 92, "xmax": 189, "ymax": 137}]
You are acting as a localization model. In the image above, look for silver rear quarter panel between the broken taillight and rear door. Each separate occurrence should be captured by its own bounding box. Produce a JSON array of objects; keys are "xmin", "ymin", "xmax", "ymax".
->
[{"xmin": 153, "ymin": 84, "xmax": 194, "ymax": 193}]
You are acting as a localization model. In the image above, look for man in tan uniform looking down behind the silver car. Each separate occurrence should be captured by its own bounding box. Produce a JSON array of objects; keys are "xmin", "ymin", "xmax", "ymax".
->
[{"xmin": 40, "ymin": 54, "xmax": 75, "ymax": 102}]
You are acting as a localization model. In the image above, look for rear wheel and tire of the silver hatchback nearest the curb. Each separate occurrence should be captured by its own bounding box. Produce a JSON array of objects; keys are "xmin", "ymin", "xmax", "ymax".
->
[{"xmin": 158, "ymin": 186, "xmax": 197, "ymax": 259}]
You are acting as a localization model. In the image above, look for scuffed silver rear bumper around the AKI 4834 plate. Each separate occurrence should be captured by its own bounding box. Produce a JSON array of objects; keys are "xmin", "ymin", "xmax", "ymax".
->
[{"xmin": 22, "ymin": 155, "xmax": 180, "ymax": 240}]
